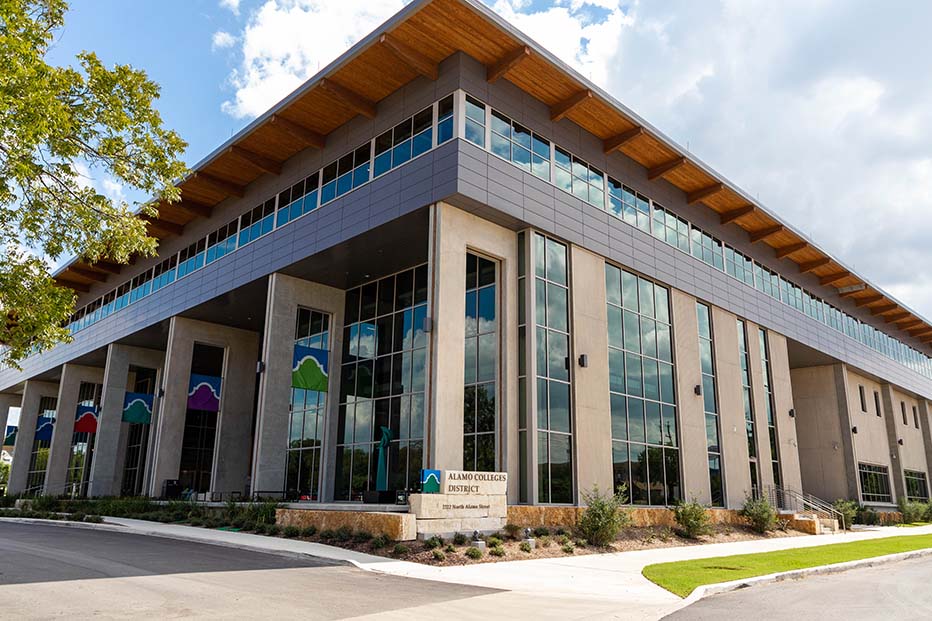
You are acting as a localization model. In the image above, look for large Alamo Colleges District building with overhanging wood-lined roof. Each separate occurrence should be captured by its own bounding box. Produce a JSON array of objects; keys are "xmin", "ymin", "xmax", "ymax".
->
[{"xmin": 0, "ymin": 0, "xmax": 932, "ymax": 508}]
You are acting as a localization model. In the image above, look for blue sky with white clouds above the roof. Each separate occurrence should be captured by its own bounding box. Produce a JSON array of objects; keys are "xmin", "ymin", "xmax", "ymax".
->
[{"xmin": 40, "ymin": 0, "xmax": 932, "ymax": 330}]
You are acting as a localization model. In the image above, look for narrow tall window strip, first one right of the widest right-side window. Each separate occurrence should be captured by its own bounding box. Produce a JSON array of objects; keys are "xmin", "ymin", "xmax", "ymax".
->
[{"xmin": 696, "ymin": 303, "xmax": 725, "ymax": 507}]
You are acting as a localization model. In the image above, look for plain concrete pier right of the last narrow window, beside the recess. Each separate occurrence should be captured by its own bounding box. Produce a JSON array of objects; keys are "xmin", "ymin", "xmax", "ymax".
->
[{"xmin": 767, "ymin": 330, "xmax": 803, "ymax": 492}]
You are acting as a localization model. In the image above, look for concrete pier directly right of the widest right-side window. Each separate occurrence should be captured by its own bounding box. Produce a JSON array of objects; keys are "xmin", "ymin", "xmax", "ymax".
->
[{"xmin": 670, "ymin": 289, "xmax": 712, "ymax": 504}]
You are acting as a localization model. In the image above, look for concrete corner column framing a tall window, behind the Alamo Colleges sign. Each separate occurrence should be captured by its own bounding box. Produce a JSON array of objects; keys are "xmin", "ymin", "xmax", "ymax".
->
[{"xmin": 425, "ymin": 203, "xmax": 518, "ymax": 502}]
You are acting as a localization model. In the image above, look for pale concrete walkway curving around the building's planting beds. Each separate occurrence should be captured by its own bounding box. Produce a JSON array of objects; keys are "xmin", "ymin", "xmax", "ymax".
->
[{"xmin": 9, "ymin": 518, "xmax": 932, "ymax": 619}]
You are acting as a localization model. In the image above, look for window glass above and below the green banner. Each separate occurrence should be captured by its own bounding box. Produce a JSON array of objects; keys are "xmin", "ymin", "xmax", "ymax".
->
[{"xmin": 285, "ymin": 308, "xmax": 330, "ymax": 500}]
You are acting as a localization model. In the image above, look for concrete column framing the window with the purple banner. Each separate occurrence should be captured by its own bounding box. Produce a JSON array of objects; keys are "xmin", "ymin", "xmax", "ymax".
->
[{"xmin": 149, "ymin": 316, "xmax": 259, "ymax": 496}]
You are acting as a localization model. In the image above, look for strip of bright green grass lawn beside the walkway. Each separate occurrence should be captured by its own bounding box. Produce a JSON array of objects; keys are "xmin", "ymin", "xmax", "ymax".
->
[{"xmin": 643, "ymin": 535, "xmax": 932, "ymax": 597}]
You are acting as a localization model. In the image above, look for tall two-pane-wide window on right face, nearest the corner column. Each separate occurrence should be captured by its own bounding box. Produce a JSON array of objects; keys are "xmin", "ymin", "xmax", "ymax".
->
[{"xmin": 534, "ymin": 233, "xmax": 574, "ymax": 503}]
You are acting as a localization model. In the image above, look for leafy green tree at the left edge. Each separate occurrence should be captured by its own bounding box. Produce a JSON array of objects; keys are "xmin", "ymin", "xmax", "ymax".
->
[{"xmin": 0, "ymin": 0, "xmax": 187, "ymax": 366}]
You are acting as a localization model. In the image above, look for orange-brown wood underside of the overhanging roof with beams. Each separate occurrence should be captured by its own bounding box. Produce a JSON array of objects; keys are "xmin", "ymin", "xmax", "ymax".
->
[{"xmin": 56, "ymin": 0, "xmax": 932, "ymax": 354}]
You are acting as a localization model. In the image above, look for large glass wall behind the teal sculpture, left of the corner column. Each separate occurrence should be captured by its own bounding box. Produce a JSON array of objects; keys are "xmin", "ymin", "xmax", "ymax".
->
[{"xmin": 334, "ymin": 265, "xmax": 428, "ymax": 500}]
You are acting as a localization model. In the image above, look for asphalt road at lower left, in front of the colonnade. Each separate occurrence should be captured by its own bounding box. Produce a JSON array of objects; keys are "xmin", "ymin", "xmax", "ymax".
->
[{"xmin": 0, "ymin": 522, "xmax": 498, "ymax": 619}]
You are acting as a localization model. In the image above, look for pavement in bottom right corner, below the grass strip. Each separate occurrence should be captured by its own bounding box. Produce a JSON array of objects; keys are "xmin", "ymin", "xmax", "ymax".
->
[{"xmin": 666, "ymin": 557, "xmax": 932, "ymax": 621}]
